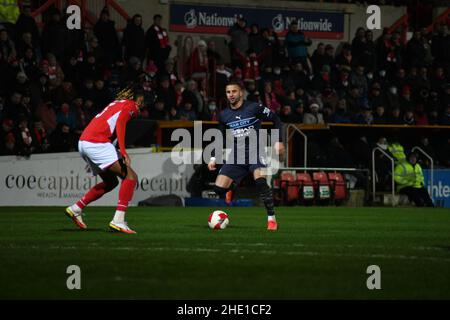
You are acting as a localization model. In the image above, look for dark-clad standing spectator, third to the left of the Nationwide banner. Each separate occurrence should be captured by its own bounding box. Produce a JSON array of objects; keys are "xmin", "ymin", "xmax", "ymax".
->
[{"xmin": 94, "ymin": 7, "xmax": 122, "ymax": 66}]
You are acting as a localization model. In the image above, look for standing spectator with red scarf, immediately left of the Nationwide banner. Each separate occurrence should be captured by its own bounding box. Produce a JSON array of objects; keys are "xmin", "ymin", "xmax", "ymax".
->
[{"xmin": 145, "ymin": 14, "xmax": 171, "ymax": 69}]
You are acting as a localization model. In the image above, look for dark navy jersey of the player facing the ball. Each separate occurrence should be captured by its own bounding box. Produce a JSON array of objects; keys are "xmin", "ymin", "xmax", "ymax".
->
[{"xmin": 219, "ymin": 101, "xmax": 283, "ymax": 163}]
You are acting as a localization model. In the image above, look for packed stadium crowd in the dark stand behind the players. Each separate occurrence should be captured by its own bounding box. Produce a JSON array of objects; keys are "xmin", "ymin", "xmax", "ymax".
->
[{"xmin": 0, "ymin": 6, "xmax": 450, "ymax": 169}]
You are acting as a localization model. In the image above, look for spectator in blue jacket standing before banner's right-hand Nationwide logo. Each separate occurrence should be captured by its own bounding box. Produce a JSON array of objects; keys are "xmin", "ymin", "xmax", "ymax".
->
[{"xmin": 284, "ymin": 20, "xmax": 312, "ymax": 66}]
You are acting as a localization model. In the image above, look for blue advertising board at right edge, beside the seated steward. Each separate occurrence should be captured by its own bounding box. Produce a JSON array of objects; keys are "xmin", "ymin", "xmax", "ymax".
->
[{"xmin": 423, "ymin": 169, "xmax": 450, "ymax": 208}]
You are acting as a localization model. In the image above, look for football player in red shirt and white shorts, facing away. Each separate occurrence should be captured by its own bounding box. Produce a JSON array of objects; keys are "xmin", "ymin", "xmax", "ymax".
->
[{"xmin": 66, "ymin": 89, "xmax": 144, "ymax": 234}]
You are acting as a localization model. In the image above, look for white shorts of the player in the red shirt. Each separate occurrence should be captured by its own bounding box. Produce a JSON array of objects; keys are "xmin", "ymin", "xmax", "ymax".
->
[{"xmin": 78, "ymin": 140, "xmax": 119, "ymax": 175}]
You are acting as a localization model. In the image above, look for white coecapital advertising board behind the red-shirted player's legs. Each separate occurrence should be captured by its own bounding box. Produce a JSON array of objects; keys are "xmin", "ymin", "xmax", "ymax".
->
[{"xmin": 0, "ymin": 149, "xmax": 194, "ymax": 206}]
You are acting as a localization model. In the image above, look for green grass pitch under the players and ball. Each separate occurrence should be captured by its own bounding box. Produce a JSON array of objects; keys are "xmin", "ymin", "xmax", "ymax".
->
[{"xmin": 0, "ymin": 207, "xmax": 450, "ymax": 299}]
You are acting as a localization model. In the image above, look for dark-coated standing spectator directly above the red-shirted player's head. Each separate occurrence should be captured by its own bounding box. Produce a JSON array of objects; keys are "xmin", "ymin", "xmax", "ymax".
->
[{"xmin": 122, "ymin": 14, "xmax": 146, "ymax": 61}]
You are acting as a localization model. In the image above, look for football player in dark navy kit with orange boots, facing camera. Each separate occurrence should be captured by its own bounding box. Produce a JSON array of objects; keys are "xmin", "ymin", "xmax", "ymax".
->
[{"xmin": 208, "ymin": 81, "xmax": 285, "ymax": 231}]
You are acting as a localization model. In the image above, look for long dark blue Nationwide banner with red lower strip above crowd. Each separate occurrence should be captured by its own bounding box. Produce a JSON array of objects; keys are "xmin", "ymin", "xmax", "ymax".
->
[{"xmin": 169, "ymin": 4, "xmax": 344, "ymax": 40}]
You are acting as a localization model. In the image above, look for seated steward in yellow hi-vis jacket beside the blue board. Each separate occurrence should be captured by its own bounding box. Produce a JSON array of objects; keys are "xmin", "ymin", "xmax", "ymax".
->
[{"xmin": 394, "ymin": 152, "xmax": 434, "ymax": 207}]
